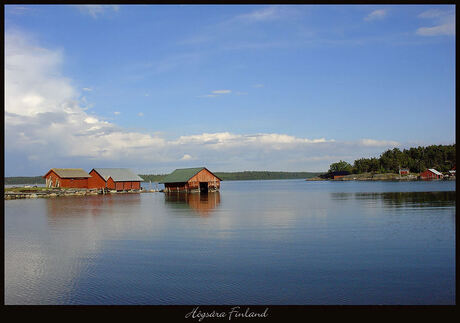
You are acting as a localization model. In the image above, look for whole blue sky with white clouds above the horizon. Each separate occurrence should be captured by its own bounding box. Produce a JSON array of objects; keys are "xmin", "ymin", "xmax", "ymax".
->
[{"xmin": 4, "ymin": 5, "xmax": 455, "ymax": 176}]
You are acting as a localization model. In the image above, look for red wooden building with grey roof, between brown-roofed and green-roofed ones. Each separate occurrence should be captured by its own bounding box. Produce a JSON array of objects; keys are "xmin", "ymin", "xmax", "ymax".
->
[{"xmin": 88, "ymin": 168, "xmax": 143, "ymax": 191}]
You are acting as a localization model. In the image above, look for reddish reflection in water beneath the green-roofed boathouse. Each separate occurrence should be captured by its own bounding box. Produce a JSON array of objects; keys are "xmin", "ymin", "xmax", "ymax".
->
[{"xmin": 165, "ymin": 192, "xmax": 220, "ymax": 217}]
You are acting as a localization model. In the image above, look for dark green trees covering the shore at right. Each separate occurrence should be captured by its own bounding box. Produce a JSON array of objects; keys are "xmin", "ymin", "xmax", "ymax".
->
[{"xmin": 329, "ymin": 144, "xmax": 456, "ymax": 174}]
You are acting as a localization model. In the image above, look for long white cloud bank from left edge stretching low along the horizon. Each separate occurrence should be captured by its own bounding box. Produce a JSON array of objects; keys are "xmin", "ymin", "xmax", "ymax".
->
[{"xmin": 5, "ymin": 32, "xmax": 399, "ymax": 176}]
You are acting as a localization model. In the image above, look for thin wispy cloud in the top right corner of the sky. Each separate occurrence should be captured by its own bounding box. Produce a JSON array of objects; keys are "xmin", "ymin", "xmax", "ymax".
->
[{"xmin": 415, "ymin": 9, "xmax": 455, "ymax": 36}]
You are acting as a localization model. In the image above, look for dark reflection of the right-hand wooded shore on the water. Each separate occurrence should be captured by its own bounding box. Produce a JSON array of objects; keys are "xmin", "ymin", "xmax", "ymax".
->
[{"xmin": 330, "ymin": 191, "xmax": 456, "ymax": 208}]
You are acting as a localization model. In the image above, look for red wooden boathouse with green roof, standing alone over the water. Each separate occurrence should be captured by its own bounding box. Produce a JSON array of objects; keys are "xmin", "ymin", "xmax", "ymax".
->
[{"xmin": 160, "ymin": 167, "xmax": 221, "ymax": 193}]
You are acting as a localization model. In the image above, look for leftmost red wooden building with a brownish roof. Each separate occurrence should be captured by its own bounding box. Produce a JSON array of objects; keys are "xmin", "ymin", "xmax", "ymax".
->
[{"xmin": 43, "ymin": 168, "xmax": 91, "ymax": 188}]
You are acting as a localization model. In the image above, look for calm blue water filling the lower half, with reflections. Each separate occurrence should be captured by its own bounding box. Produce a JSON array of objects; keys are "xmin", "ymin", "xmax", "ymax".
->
[{"xmin": 5, "ymin": 180, "xmax": 456, "ymax": 305}]
